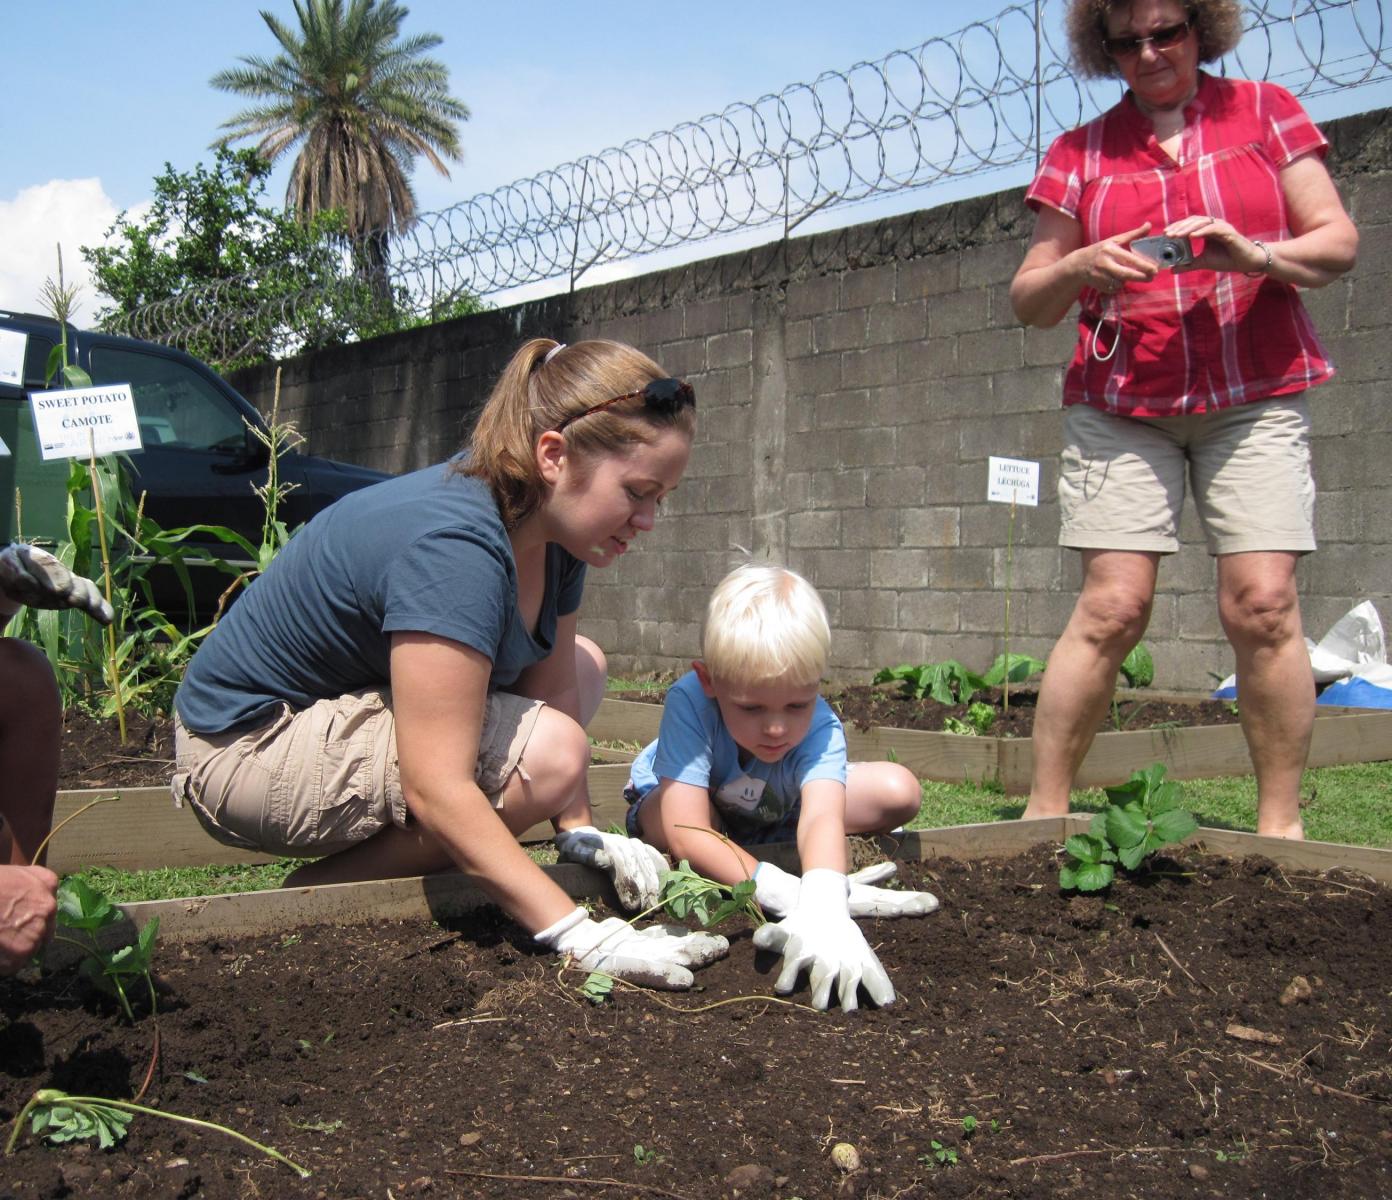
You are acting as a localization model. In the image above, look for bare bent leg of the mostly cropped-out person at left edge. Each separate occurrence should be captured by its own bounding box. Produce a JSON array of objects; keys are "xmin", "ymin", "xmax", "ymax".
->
[{"xmin": 0, "ymin": 638, "xmax": 63, "ymax": 866}]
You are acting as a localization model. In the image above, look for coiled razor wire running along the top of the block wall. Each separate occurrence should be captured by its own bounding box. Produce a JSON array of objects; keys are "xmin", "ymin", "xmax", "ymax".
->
[{"xmin": 119, "ymin": 0, "xmax": 1392, "ymax": 362}]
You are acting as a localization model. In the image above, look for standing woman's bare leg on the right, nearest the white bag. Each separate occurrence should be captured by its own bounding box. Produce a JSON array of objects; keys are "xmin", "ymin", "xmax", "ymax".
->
[{"xmin": 1218, "ymin": 551, "xmax": 1314, "ymax": 838}]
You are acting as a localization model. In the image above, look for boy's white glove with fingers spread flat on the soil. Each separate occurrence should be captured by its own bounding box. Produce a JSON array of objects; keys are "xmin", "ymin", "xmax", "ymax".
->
[{"xmin": 754, "ymin": 867, "xmax": 894, "ymax": 1012}]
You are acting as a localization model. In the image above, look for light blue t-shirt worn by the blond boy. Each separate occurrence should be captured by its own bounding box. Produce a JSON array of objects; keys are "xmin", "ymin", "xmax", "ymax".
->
[{"xmin": 629, "ymin": 671, "xmax": 846, "ymax": 831}]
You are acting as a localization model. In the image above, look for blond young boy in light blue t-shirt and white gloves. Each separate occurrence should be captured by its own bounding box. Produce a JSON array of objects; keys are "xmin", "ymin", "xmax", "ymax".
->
[{"xmin": 626, "ymin": 564, "xmax": 938, "ymax": 1011}]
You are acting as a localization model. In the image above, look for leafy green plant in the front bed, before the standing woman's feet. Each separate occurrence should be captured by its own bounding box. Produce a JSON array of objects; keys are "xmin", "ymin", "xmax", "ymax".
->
[{"xmin": 1058, "ymin": 763, "xmax": 1199, "ymax": 891}]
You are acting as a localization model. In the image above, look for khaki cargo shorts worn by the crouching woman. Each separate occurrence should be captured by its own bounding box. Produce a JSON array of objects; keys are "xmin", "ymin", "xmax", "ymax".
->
[{"xmin": 171, "ymin": 688, "xmax": 544, "ymax": 858}]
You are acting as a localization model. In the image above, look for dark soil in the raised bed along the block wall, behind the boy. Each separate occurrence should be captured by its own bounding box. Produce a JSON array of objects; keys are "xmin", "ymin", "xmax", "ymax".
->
[{"xmin": 610, "ymin": 685, "xmax": 1237, "ymax": 738}]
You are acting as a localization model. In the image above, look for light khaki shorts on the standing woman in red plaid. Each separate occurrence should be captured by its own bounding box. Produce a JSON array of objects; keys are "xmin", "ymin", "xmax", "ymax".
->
[{"xmin": 1058, "ymin": 397, "xmax": 1315, "ymax": 554}]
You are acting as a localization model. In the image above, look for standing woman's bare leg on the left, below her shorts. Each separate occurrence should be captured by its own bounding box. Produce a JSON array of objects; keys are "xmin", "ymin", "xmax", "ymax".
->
[{"xmin": 1025, "ymin": 550, "xmax": 1160, "ymax": 817}]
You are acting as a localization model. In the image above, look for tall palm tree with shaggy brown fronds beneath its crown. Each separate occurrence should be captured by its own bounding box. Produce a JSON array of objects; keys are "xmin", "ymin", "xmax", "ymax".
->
[{"xmin": 212, "ymin": 0, "xmax": 469, "ymax": 299}]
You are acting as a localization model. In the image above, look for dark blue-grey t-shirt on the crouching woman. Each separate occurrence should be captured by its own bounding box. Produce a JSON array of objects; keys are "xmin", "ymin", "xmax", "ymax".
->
[{"xmin": 174, "ymin": 464, "xmax": 585, "ymax": 734}]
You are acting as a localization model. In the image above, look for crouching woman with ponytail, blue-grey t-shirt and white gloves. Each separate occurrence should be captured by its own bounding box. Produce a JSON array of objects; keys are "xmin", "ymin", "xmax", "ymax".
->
[{"xmin": 173, "ymin": 338, "xmax": 725, "ymax": 987}]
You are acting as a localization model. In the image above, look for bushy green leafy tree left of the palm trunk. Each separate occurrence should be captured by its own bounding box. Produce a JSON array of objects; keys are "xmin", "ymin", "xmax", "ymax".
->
[{"xmin": 82, "ymin": 148, "xmax": 372, "ymax": 369}]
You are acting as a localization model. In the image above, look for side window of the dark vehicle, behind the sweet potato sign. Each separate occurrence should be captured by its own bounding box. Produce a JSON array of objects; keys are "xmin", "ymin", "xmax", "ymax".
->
[{"xmin": 92, "ymin": 347, "xmax": 246, "ymax": 450}]
